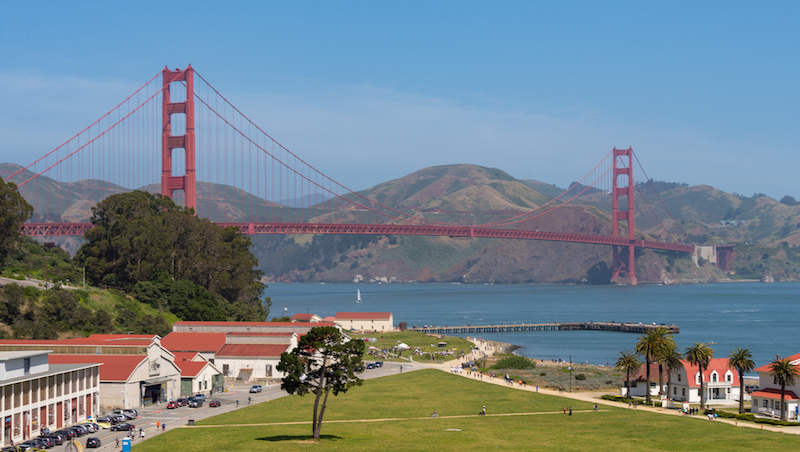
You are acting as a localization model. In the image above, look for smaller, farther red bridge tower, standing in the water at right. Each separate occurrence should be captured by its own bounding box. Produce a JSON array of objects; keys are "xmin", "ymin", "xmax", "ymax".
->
[{"xmin": 611, "ymin": 147, "xmax": 636, "ymax": 285}]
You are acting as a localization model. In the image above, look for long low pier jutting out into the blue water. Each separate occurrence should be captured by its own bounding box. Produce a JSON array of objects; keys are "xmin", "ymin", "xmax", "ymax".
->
[{"xmin": 408, "ymin": 322, "xmax": 681, "ymax": 334}]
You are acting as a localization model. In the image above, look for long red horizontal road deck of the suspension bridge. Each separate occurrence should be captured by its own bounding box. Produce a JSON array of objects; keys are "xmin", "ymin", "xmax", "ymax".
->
[{"xmin": 21, "ymin": 223, "xmax": 694, "ymax": 253}]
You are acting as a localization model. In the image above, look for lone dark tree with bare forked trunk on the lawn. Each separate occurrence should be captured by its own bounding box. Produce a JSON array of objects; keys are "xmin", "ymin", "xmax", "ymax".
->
[{"xmin": 277, "ymin": 326, "xmax": 364, "ymax": 439}]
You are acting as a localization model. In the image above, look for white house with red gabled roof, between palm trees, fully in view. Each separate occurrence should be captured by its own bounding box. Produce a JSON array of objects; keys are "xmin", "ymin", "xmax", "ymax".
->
[{"xmin": 665, "ymin": 358, "xmax": 741, "ymax": 404}]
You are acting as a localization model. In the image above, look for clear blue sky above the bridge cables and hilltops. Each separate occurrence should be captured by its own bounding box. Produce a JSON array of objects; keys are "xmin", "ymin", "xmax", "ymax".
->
[{"xmin": 0, "ymin": 0, "xmax": 800, "ymax": 199}]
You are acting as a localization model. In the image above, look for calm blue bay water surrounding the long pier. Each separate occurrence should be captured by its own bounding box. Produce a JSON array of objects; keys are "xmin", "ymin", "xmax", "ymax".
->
[{"xmin": 267, "ymin": 282, "xmax": 800, "ymax": 366}]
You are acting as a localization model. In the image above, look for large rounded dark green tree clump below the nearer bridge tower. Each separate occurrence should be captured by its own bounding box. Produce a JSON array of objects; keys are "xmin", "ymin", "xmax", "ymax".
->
[{"xmin": 75, "ymin": 191, "xmax": 269, "ymax": 321}]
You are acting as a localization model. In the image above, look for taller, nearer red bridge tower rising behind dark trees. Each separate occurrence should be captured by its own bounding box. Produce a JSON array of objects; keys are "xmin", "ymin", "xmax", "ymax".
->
[{"xmin": 161, "ymin": 65, "xmax": 197, "ymax": 214}]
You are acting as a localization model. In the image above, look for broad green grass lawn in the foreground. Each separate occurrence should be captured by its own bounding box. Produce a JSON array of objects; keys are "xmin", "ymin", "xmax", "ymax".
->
[{"xmin": 134, "ymin": 370, "xmax": 800, "ymax": 452}]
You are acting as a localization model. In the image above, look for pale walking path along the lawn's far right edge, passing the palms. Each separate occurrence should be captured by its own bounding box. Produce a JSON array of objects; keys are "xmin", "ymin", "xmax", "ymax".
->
[{"xmin": 418, "ymin": 340, "xmax": 800, "ymax": 435}]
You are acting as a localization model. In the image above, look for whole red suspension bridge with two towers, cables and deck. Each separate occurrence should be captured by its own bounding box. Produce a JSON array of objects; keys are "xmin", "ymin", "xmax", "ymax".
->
[{"xmin": 2, "ymin": 66, "xmax": 733, "ymax": 284}]
